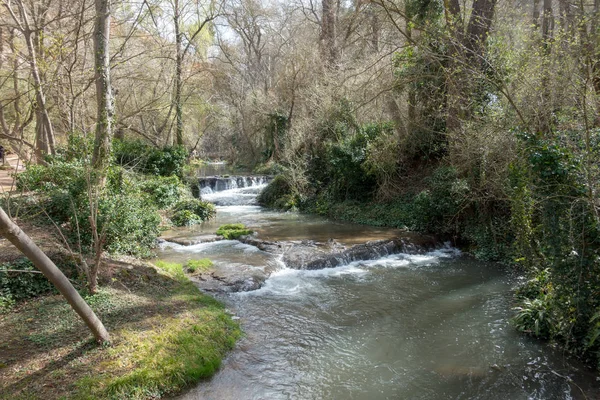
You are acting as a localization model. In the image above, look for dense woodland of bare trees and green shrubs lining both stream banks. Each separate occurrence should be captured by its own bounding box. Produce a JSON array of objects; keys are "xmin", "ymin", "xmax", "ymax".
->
[{"xmin": 0, "ymin": 0, "xmax": 600, "ymax": 374}]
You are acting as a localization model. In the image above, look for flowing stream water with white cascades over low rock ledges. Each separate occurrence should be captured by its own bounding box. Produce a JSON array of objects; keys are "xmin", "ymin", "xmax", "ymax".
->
[{"xmin": 161, "ymin": 165, "xmax": 600, "ymax": 400}]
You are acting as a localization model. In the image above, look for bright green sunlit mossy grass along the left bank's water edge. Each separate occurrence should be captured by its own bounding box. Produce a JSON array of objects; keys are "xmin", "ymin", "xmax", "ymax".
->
[{"xmin": 77, "ymin": 281, "xmax": 240, "ymax": 399}]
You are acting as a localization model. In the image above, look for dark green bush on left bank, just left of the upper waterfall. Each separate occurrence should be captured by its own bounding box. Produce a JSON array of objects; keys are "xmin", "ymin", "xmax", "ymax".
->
[{"xmin": 113, "ymin": 140, "xmax": 189, "ymax": 177}]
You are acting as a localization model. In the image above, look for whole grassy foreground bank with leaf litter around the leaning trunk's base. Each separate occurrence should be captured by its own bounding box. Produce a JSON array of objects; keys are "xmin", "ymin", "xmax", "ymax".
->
[{"xmin": 0, "ymin": 262, "xmax": 241, "ymax": 399}]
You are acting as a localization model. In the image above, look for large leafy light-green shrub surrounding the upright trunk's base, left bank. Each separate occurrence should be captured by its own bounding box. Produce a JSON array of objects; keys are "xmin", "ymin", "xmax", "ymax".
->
[{"xmin": 17, "ymin": 160, "xmax": 162, "ymax": 256}]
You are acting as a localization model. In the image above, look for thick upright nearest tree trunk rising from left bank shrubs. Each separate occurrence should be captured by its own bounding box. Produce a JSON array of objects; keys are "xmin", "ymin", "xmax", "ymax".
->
[{"xmin": 92, "ymin": 0, "xmax": 114, "ymax": 170}]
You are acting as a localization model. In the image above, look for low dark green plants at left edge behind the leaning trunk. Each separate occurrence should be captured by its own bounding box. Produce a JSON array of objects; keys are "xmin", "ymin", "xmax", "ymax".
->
[{"xmin": 0, "ymin": 259, "xmax": 56, "ymax": 310}]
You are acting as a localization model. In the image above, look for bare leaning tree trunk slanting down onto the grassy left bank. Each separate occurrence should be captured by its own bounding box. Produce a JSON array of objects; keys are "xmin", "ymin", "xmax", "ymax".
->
[{"xmin": 0, "ymin": 207, "xmax": 110, "ymax": 343}]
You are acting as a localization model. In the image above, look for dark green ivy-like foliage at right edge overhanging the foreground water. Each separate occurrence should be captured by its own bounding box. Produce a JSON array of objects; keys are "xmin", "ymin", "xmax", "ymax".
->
[{"xmin": 510, "ymin": 132, "xmax": 600, "ymax": 362}]
